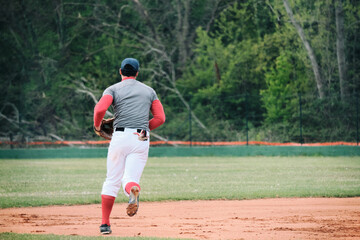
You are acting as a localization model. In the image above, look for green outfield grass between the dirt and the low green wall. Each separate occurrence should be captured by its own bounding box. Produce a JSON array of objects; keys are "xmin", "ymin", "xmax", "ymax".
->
[{"xmin": 0, "ymin": 157, "xmax": 360, "ymax": 208}]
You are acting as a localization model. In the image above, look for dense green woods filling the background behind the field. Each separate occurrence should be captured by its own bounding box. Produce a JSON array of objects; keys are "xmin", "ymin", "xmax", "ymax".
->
[{"xmin": 0, "ymin": 0, "xmax": 360, "ymax": 142}]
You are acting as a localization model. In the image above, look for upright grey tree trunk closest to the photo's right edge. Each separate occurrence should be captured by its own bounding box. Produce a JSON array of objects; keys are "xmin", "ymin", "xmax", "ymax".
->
[{"xmin": 335, "ymin": 0, "xmax": 347, "ymax": 101}]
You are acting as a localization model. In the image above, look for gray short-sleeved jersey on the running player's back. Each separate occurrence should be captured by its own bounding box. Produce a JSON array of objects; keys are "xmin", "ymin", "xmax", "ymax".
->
[{"xmin": 103, "ymin": 79, "xmax": 158, "ymax": 131}]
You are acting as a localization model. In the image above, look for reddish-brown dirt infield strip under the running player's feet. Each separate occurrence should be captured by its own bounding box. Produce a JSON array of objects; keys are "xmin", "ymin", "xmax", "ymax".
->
[{"xmin": 0, "ymin": 198, "xmax": 360, "ymax": 239}]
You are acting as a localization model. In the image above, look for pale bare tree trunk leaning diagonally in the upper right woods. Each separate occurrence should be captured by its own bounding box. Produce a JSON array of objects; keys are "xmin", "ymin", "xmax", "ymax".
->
[{"xmin": 283, "ymin": 0, "xmax": 325, "ymax": 98}]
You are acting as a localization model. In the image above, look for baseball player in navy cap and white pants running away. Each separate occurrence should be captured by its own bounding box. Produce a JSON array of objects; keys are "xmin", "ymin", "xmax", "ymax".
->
[{"xmin": 94, "ymin": 58, "xmax": 165, "ymax": 234}]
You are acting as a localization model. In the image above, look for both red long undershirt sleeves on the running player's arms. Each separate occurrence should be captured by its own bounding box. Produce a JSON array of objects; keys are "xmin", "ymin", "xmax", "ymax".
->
[{"xmin": 94, "ymin": 95, "xmax": 165, "ymax": 131}]
